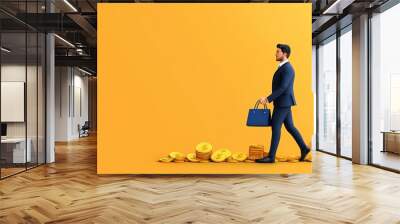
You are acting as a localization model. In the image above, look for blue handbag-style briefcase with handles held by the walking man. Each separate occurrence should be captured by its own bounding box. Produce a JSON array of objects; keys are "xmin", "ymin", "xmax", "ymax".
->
[{"xmin": 247, "ymin": 100, "xmax": 271, "ymax": 127}]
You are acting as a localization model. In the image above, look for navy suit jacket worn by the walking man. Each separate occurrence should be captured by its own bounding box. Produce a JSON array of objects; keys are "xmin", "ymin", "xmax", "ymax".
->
[{"xmin": 267, "ymin": 62, "xmax": 296, "ymax": 107}]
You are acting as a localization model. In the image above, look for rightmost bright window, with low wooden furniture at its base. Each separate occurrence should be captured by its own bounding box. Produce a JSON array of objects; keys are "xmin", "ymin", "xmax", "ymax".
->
[{"xmin": 370, "ymin": 2, "xmax": 400, "ymax": 170}]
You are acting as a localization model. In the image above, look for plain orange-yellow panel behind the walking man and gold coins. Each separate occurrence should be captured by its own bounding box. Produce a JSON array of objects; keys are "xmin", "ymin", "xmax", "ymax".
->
[{"xmin": 97, "ymin": 3, "xmax": 313, "ymax": 174}]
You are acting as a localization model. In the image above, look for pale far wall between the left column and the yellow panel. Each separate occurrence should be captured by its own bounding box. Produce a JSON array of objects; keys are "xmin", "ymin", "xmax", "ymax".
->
[{"xmin": 55, "ymin": 67, "xmax": 89, "ymax": 141}]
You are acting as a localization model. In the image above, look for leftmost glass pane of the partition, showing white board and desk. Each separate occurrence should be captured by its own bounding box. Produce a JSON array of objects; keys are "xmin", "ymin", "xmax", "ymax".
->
[{"xmin": 0, "ymin": 32, "xmax": 27, "ymax": 178}]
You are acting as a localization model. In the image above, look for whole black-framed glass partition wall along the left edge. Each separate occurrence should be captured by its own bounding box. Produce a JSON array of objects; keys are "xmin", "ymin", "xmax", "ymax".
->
[{"xmin": 0, "ymin": 1, "xmax": 46, "ymax": 179}]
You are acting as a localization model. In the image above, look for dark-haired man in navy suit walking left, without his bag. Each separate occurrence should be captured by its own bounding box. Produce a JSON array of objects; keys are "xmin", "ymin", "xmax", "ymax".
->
[{"xmin": 256, "ymin": 44, "xmax": 310, "ymax": 163}]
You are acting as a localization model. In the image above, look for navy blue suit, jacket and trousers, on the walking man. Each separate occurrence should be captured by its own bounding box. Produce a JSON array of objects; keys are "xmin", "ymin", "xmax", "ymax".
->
[{"xmin": 267, "ymin": 62, "xmax": 308, "ymax": 158}]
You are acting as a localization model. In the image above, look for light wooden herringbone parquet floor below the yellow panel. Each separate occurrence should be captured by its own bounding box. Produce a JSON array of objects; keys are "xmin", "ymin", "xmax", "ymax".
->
[{"xmin": 0, "ymin": 134, "xmax": 400, "ymax": 224}]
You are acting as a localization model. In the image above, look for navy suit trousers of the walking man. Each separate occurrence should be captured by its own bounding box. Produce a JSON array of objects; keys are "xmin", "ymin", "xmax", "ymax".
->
[{"xmin": 269, "ymin": 107, "xmax": 308, "ymax": 158}]
